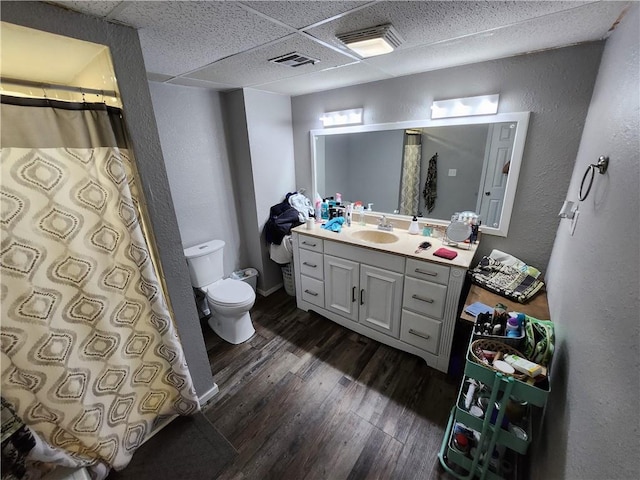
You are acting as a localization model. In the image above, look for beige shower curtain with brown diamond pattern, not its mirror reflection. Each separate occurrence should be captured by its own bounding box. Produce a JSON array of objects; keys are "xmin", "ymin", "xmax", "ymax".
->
[{"xmin": 0, "ymin": 96, "xmax": 200, "ymax": 477}]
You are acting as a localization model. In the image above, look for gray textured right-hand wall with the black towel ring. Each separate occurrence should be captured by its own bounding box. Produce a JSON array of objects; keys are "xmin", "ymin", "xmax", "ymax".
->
[{"xmin": 532, "ymin": 4, "xmax": 640, "ymax": 480}]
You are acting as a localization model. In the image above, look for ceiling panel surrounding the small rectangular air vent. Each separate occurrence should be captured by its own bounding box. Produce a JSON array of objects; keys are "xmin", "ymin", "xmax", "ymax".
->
[{"xmin": 187, "ymin": 33, "xmax": 353, "ymax": 87}]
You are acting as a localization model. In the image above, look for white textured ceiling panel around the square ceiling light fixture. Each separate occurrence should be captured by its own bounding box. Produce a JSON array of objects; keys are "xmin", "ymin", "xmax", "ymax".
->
[{"xmin": 308, "ymin": 1, "xmax": 586, "ymax": 53}]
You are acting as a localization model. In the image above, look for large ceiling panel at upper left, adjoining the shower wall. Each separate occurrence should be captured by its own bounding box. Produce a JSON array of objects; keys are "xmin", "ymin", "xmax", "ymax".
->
[{"xmin": 114, "ymin": 2, "xmax": 291, "ymax": 75}]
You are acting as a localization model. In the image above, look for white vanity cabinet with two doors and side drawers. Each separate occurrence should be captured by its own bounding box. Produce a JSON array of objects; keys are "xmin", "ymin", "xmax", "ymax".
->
[{"xmin": 293, "ymin": 227, "xmax": 471, "ymax": 372}]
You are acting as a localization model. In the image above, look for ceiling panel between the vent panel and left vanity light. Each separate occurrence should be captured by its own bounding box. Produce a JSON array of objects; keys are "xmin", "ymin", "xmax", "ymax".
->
[{"xmin": 254, "ymin": 62, "xmax": 392, "ymax": 96}]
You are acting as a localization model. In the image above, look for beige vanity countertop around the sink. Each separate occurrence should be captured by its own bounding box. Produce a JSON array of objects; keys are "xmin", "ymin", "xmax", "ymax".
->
[{"xmin": 292, "ymin": 223, "xmax": 478, "ymax": 269}]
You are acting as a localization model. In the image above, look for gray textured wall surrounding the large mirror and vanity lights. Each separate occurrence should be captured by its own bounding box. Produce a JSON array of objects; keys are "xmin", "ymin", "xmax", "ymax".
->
[{"xmin": 292, "ymin": 43, "xmax": 602, "ymax": 270}]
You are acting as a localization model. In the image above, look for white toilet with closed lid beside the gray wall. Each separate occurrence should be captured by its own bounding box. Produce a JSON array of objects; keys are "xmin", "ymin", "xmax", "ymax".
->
[{"xmin": 184, "ymin": 240, "xmax": 256, "ymax": 344}]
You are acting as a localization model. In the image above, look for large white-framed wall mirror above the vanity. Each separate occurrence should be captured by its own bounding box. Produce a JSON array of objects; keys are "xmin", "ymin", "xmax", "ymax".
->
[{"xmin": 311, "ymin": 112, "xmax": 529, "ymax": 236}]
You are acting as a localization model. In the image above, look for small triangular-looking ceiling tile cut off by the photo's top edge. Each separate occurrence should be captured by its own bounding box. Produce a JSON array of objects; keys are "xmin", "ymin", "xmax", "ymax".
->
[{"xmin": 242, "ymin": 1, "xmax": 372, "ymax": 28}]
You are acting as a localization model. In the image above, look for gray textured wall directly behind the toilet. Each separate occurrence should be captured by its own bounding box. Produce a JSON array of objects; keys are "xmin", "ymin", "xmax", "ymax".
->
[{"xmin": 149, "ymin": 82, "xmax": 247, "ymax": 275}]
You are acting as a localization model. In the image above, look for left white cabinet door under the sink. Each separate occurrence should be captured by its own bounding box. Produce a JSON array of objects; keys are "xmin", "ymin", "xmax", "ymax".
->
[{"xmin": 324, "ymin": 255, "xmax": 360, "ymax": 322}]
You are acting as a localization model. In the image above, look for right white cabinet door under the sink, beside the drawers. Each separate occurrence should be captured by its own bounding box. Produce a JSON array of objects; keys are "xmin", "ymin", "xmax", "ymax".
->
[{"xmin": 359, "ymin": 265, "xmax": 404, "ymax": 338}]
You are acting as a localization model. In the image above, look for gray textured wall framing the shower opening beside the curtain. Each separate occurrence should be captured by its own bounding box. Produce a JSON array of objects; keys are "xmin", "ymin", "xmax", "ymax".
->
[{"xmin": 2, "ymin": 2, "xmax": 214, "ymax": 395}]
